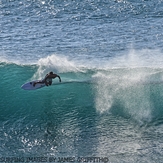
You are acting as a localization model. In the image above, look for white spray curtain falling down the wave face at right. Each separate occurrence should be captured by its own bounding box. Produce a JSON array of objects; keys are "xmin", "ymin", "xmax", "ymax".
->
[{"xmin": 93, "ymin": 68, "xmax": 161, "ymax": 123}]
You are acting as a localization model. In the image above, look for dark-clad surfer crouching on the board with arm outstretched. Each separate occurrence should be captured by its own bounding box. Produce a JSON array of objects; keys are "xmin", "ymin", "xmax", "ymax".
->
[{"xmin": 33, "ymin": 71, "xmax": 61, "ymax": 87}]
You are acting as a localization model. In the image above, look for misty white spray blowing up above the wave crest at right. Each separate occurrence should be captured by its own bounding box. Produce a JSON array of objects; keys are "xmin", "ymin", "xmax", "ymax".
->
[{"xmin": 106, "ymin": 49, "xmax": 163, "ymax": 68}]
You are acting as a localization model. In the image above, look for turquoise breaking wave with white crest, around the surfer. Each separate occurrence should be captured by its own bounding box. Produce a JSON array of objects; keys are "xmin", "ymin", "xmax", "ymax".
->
[{"xmin": 0, "ymin": 53, "xmax": 163, "ymax": 123}]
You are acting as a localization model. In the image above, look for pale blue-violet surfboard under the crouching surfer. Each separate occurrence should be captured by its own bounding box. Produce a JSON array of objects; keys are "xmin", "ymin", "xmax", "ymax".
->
[{"xmin": 21, "ymin": 80, "xmax": 45, "ymax": 90}]
